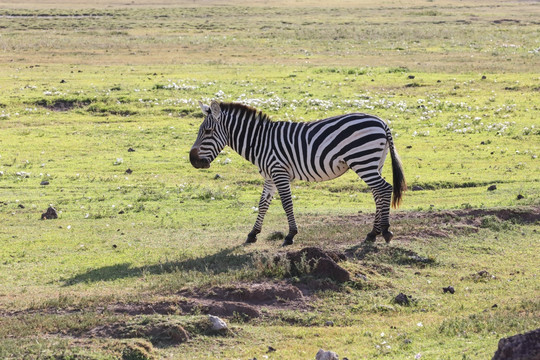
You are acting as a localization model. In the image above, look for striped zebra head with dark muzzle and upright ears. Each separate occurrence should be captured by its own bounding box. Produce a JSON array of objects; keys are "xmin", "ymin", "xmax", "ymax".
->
[{"xmin": 189, "ymin": 101, "xmax": 227, "ymax": 169}]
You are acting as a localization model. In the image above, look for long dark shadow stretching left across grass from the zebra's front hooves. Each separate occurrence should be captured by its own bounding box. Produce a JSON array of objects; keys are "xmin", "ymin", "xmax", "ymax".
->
[{"xmin": 62, "ymin": 246, "xmax": 253, "ymax": 287}]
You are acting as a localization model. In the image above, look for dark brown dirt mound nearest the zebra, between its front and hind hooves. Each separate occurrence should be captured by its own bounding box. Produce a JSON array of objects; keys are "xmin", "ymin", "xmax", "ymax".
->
[{"xmin": 285, "ymin": 247, "xmax": 351, "ymax": 283}]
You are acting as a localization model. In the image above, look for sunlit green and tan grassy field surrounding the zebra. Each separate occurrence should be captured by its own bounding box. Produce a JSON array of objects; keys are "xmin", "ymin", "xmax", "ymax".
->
[{"xmin": 0, "ymin": 0, "xmax": 540, "ymax": 360}]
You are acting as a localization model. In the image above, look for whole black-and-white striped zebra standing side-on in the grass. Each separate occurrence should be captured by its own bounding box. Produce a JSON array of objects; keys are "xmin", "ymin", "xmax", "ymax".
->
[{"xmin": 189, "ymin": 101, "xmax": 407, "ymax": 246}]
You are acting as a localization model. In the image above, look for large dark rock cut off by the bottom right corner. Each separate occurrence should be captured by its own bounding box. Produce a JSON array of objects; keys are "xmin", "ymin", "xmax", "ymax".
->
[{"xmin": 492, "ymin": 328, "xmax": 540, "ymax": 360}]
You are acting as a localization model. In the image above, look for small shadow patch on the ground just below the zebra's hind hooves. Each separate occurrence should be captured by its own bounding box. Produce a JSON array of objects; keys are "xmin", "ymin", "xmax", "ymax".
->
[{"xmin": 345, "ymin": 242, "xmax": 437, "ymax": 267}]
